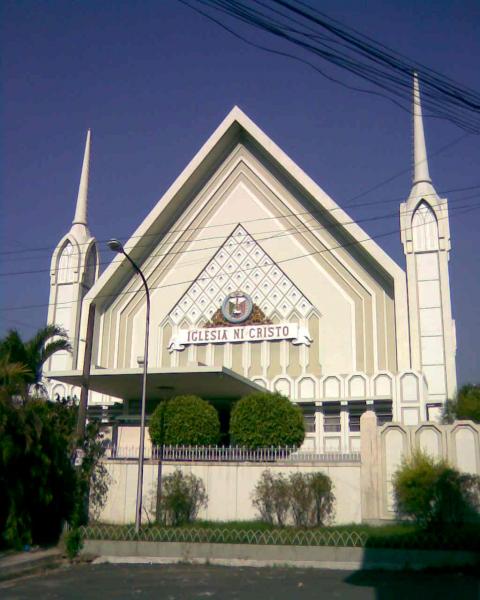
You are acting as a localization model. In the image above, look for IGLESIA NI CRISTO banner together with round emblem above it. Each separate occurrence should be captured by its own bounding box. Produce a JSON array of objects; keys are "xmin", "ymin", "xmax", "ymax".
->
[{"xmin": 168, "ymin": 292, "xmax": 312, "ymax": 352}]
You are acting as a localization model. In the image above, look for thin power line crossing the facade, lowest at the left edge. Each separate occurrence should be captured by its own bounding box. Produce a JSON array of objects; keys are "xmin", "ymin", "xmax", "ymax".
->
[{"xmin": 0, "ymin": 200, "xmax": 480, "ymax": 311}]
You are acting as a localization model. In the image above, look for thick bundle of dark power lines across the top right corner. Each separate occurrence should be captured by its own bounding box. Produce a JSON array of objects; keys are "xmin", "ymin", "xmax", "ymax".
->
[{"xmin": 183, "ymin": 0, "xmax": 480, "ymax": 133}]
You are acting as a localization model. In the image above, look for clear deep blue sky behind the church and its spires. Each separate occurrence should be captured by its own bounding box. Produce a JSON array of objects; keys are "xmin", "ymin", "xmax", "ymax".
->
[{"xmin": 0, "ymin": 0, "xmax": 480, "ymax": 383}]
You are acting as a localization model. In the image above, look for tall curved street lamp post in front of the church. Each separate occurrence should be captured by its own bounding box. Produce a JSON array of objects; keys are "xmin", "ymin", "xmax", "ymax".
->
[{"xmin": 107, "ymin": 239, "xmax": 150, "ymax": 533}]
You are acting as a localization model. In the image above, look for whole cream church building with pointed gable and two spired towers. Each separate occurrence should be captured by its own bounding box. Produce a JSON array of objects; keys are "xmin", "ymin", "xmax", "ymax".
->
[{"xmin": 45, "ymin": 80, "xmax": 456, "ymax": 452}]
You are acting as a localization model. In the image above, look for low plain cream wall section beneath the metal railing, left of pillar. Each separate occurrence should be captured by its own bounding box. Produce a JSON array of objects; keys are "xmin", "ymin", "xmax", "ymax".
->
[{"xmin": 99, "ymin": 460, "xmax": 361, "ymax": 523}]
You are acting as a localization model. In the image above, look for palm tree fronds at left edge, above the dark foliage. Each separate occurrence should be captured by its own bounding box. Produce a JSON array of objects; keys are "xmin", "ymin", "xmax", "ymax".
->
[{"xmin": 0, "ymin": 325, "xmax": 72, "ymax": 398}]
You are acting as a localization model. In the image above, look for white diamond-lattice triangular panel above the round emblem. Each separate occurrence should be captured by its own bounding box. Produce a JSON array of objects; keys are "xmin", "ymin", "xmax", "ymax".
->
[{"xmin": 170, "ymin": 225, "xmax": 312, "ymax": 326}]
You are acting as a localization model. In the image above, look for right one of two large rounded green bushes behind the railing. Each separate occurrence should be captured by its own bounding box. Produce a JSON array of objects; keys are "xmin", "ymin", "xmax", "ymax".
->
[{"xmin": 230, "ymin": 392, "xmax": 305, "ymax": 448}]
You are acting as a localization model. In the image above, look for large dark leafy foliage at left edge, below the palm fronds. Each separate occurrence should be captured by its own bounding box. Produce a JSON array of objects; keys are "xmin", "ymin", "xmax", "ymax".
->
[{"xmin": 0, "ymin": 394, "xmax": 109, "ymax": 548}]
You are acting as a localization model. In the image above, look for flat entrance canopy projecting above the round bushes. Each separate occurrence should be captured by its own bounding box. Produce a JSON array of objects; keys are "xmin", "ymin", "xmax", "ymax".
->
[{"xmin": 45, "ymin": 365, "xmax": 265, "ymax": 400}]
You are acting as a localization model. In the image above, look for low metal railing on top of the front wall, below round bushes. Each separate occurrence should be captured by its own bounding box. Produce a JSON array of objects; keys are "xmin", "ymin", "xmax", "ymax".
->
[{"xmin": 105, "ymin": 446, "xmax": 360, "ymax": 463}]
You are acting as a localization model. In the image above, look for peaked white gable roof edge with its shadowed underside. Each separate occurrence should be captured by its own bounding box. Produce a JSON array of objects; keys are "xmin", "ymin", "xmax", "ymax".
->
[{"xmin": 89, "ymin": 107, "xmax": 404, "ymax": 310}]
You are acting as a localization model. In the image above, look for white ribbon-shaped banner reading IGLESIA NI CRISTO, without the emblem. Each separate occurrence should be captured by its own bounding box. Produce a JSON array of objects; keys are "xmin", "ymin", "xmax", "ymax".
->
[{"xmin": 168, "ymin": 323, "xmax": 312, "ymax": 352}]
